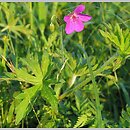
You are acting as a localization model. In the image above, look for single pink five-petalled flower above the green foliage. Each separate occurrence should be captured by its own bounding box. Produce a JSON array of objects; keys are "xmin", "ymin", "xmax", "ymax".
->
[{"xmin": 64, "ymin": 5, "xmax": 92, "ymax": 34}]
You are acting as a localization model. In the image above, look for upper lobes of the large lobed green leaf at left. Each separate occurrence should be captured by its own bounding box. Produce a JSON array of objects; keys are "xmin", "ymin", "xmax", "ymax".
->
[{"xmin": 4, "ymin": 53, "xmax": 49, "ymax": 85}]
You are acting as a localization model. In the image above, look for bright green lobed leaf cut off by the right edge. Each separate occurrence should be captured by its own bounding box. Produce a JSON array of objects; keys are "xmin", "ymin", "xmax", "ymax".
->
[{"xmin": 100, "ymin": 23, "xmax": 130, "ymax": 56}]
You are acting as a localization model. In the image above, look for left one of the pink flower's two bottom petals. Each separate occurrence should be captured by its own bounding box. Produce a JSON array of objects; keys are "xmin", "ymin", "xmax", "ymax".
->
[{"xmin": 65, "ymin": 20, "xmax": 75, "ymax": 34}]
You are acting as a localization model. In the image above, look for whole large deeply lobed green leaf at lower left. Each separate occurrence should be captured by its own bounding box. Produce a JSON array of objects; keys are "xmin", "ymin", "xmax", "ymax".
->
[{"xmin": 0, "ymin": 52, "xmax": 58, "ymax": 125}]
